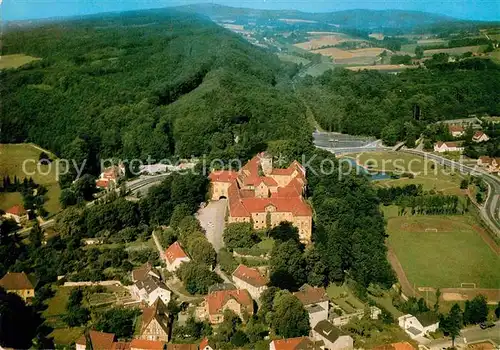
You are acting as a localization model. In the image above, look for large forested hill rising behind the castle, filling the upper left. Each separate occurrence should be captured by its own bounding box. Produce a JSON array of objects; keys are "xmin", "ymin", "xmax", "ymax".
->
[{"xmin": 0, "ymin": 10, "xmax": 310, "ymax": 167}]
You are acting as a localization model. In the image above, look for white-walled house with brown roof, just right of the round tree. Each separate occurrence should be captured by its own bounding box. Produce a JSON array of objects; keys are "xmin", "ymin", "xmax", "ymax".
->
[{"xmin": 293, "ymin": 284, "xmax": 330, "ymax": 328}]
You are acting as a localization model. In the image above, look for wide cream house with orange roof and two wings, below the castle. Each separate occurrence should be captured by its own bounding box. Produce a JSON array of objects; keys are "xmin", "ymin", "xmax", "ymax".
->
[{"xmin": 203, "ymin": 289, "xmax": 254, "ymax": 324}]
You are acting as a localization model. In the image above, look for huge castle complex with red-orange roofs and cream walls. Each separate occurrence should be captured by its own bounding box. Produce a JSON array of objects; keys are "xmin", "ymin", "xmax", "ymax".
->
[{"xmin": 209, "ymin": 153, "xmax": 312, "ymax": 243}]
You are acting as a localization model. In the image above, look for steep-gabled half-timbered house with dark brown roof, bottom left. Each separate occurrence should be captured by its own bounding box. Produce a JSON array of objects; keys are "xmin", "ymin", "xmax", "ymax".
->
[{"xmin": 139, "ymin": 298, "xmax": 170, "ymax": 342}]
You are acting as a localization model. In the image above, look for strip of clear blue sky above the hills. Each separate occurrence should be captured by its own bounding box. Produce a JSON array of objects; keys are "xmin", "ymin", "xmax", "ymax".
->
[{"xmin": 0, "ymin": 0, "xmax": 500, "ymax": 21}]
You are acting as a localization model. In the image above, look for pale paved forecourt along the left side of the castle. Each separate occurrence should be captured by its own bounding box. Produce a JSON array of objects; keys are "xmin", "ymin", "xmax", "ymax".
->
[{"xmin": 196, "ymin": 199, "xmax": 227, "ymax": 252}]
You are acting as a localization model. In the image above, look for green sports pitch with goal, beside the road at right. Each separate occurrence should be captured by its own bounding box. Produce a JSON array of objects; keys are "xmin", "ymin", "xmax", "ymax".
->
[{"xmin": 386, "ymin": 212, "xmax": 500, "ymax": 288}]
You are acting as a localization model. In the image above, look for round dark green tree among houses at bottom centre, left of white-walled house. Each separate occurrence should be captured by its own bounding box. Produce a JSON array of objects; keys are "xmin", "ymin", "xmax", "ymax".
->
[{"xmin": 271, "ymin": 291, "xmax": 310, "ymax": 338}]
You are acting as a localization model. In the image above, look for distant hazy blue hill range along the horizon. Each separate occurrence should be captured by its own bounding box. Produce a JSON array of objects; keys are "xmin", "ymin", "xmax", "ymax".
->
[{"xmin": 177, "ymin": 4, "xmax": 457, "ymax": 30}]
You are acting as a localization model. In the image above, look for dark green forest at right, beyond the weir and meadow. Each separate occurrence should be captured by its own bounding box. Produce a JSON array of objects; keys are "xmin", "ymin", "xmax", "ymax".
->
[{"xmin": 298, "ymin": 57, "xmax": 500, "ymax": 144}]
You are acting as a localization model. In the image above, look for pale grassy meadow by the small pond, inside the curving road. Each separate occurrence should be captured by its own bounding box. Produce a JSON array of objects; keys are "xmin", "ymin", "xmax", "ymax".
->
[{"xmin": 350, "ymin": 152, "xmax": 465, "ymax": 195}]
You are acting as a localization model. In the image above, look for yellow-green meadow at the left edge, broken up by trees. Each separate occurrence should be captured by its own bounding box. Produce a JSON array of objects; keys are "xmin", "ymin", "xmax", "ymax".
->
[{"xmin": 0, "ymin": 143, "xmax": 61, "ymax": 214}]
